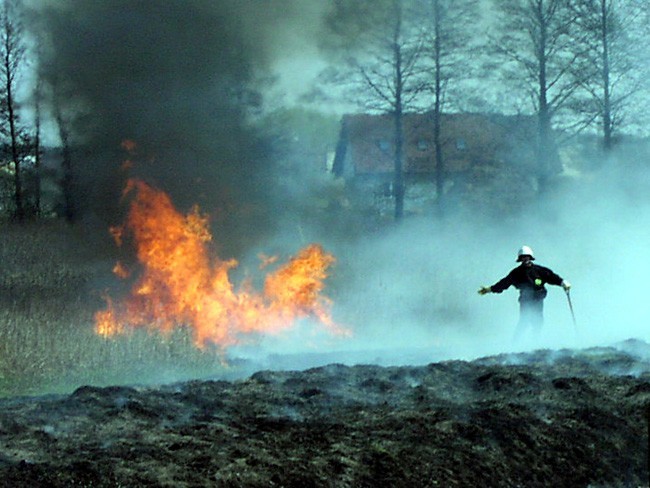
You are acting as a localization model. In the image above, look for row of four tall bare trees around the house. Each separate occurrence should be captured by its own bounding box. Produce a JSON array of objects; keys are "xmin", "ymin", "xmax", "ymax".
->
[{"xmin": 322, "ymin": 0, "xmax": 650, "ymax": 219}]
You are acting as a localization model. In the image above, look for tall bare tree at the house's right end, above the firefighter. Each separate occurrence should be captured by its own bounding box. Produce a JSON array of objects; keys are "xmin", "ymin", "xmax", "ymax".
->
[{"xmin": 491, "ymin": 0, "xmax": 583, "ymax": 191}]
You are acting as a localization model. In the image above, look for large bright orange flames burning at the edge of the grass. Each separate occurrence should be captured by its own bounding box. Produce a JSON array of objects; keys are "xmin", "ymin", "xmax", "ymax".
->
[{"xmin": 95, "ymin": 179, "xmax": 349, "ymax": 348}]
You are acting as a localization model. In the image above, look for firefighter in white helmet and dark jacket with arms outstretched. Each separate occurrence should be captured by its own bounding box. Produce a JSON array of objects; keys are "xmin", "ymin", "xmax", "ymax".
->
[{"xmin": 478, "ymin": 246, "xmax": 571, "ymax": 337}]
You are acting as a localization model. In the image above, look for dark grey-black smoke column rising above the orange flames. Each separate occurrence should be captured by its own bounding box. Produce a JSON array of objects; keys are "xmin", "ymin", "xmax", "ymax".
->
[{"xmin": 27, "ymin": 0, "xmax": 330, "ymax": 247}]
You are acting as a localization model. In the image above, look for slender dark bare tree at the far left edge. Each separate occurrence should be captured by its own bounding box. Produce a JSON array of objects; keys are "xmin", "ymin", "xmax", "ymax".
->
[{"xmin": 0, "ymin": 0, "xmax": 26, "ymax": 221}]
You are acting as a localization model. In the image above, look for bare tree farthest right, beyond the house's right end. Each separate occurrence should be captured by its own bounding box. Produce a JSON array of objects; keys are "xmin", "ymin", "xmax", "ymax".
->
[{"xmin": 573, "ymin": 0, "xmax": 649, "ymax": 153}]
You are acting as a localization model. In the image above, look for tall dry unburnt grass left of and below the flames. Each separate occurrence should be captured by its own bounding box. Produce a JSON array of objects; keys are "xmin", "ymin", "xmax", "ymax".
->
[{"xmin": 0, "ymin": 222, "xmax": 236, "ymax": 396}]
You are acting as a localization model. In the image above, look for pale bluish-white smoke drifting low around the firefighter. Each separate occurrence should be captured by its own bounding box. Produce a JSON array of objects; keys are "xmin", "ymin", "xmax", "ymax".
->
[{"xmin": 238, "ymin": 149, "xmax": 650, "ymax": 368}]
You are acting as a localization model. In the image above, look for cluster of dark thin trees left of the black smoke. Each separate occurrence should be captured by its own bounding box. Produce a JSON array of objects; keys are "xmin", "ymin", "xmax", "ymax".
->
[{"xmin": 0, "ymin": 0, "xmax": 76, "ymax": 222}]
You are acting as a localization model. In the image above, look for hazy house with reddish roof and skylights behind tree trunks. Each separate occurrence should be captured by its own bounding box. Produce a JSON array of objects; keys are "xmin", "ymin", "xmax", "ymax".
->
[{"xmin": 332, "ymin": 113, "xmax": 560, "ymax": 213}]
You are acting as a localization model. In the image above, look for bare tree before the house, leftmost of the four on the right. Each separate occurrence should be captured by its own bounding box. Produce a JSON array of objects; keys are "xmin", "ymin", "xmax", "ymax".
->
[{"xmin": 325, "ymin": 0, "xmax": 427, "ymax": 220}]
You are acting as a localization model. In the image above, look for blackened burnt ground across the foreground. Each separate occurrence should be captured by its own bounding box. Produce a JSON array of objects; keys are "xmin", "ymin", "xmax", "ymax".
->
[{"xmin": 0, "ymin": 340, "xmax": 650, "ymax": 488}]
